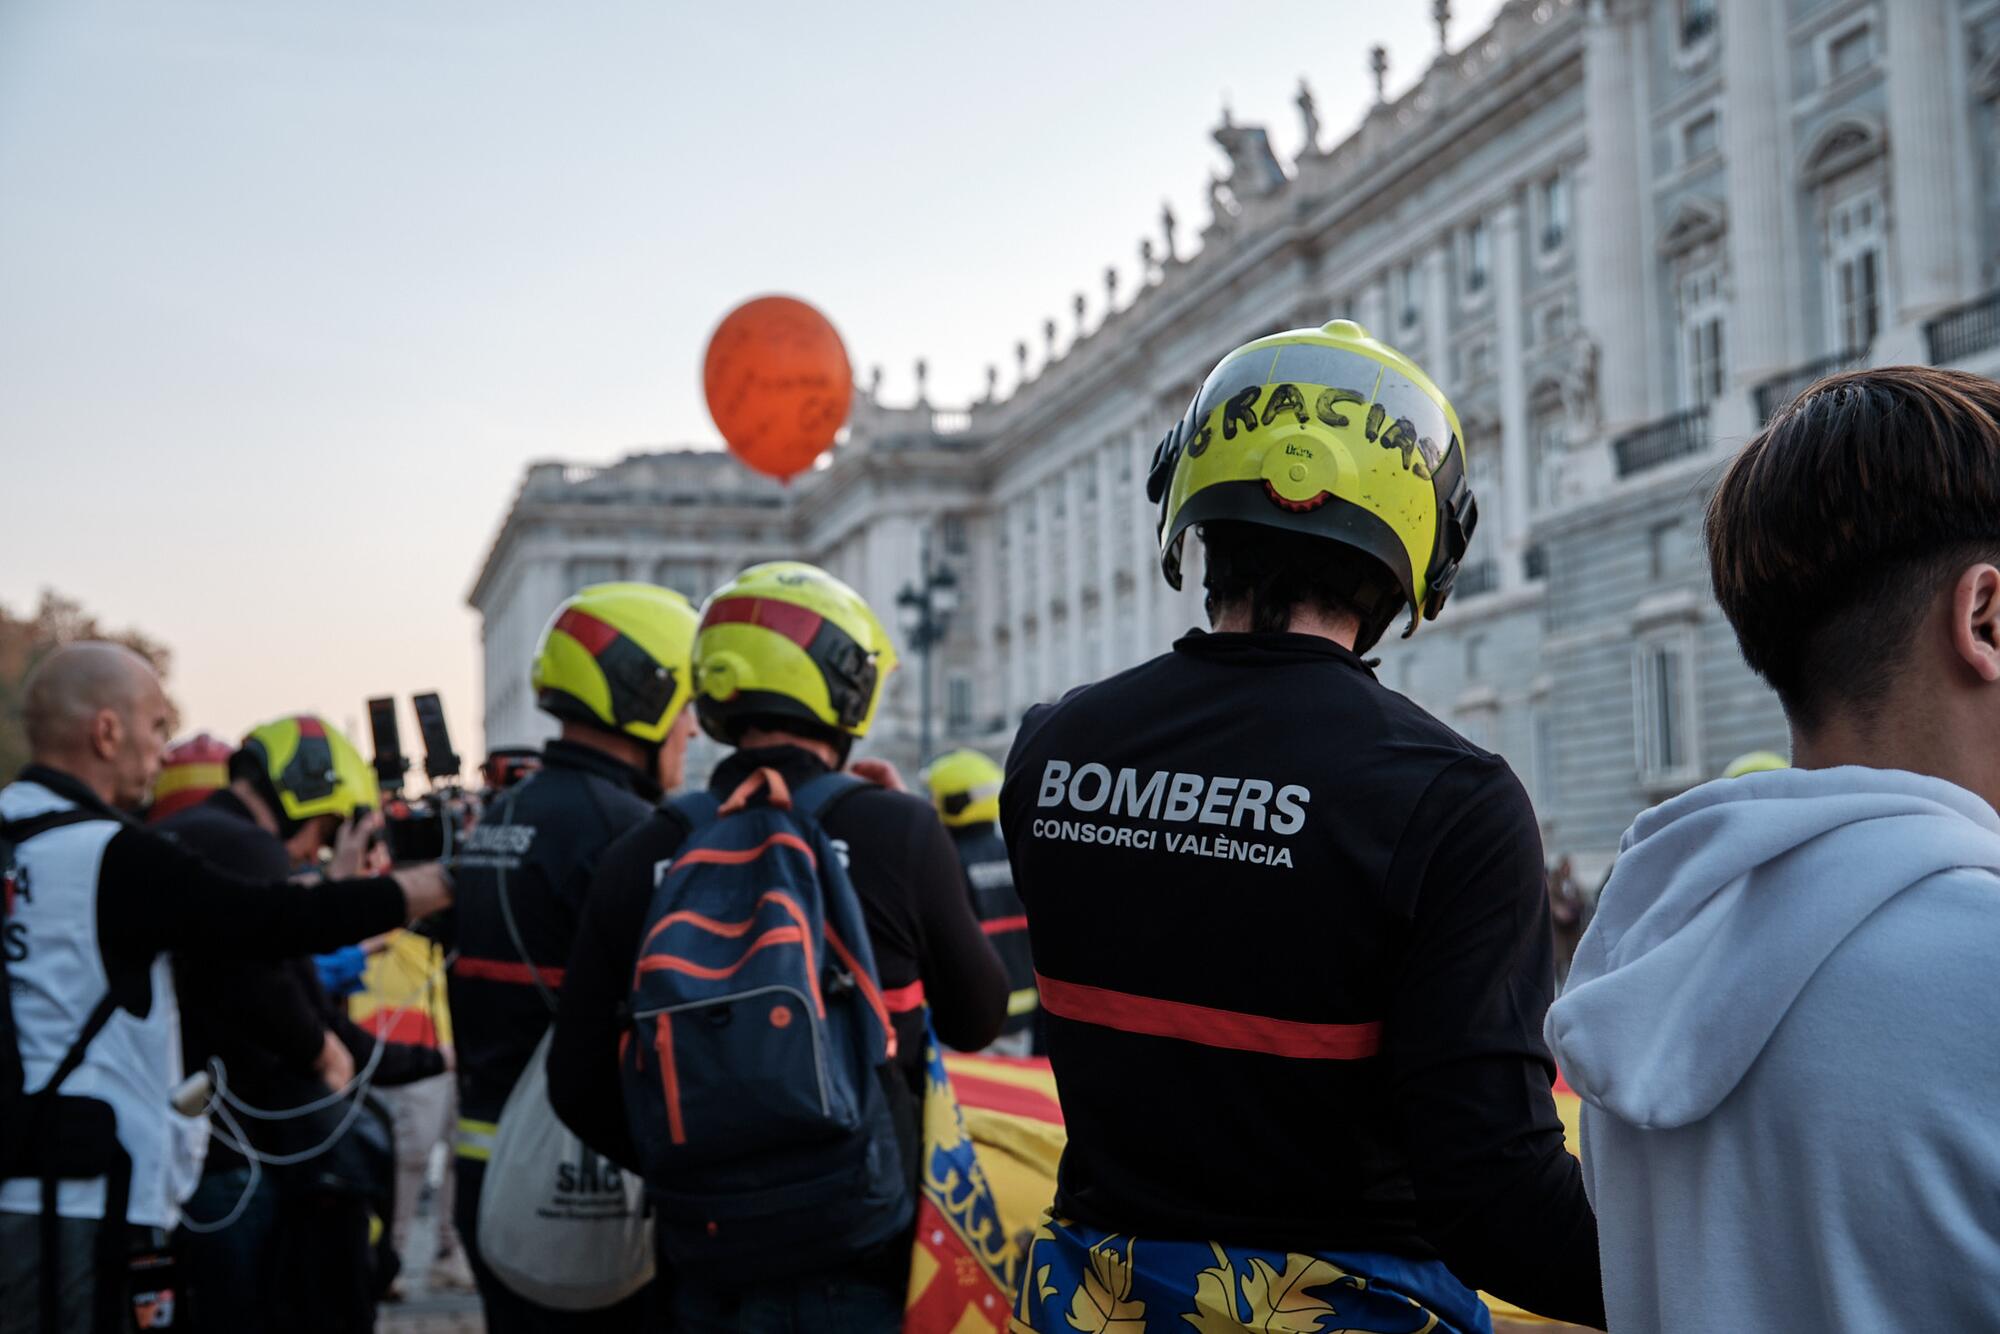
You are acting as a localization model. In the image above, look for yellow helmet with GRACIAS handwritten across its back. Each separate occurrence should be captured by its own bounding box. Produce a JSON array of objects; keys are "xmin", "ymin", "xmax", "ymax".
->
[{"xmin": 1146, "ymin": 320, "xmax": 1478, "ymax": 634}]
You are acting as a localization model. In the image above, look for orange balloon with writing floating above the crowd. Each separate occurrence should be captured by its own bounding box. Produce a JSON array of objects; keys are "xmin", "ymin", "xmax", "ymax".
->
[{"xmin": 702, "ymin": 296, "xmax": 854, "ymax": 478}]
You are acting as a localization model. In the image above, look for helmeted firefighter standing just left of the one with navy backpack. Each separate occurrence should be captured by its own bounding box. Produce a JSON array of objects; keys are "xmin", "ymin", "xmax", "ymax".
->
[{"xmin": 444, "ymin": 582, "xmax": 696, "ymax": 1334}]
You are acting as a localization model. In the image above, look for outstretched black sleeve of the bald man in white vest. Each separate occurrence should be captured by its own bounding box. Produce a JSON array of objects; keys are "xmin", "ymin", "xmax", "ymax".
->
[{"xmin": 98, "ymin": 826, "xmax": 406, "ymax": 972}]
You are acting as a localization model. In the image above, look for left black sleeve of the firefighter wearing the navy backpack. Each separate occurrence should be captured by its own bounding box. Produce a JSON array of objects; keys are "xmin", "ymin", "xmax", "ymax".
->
[{"xmin": 548, "ymin": 814, "xmax": 684, "ymax": 1172}]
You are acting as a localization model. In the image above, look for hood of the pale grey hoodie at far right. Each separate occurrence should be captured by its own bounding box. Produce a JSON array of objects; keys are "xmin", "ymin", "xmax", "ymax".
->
[{"xmin": 1544, "ymin": 768, "xmax": 2000, "ymax": 1128}]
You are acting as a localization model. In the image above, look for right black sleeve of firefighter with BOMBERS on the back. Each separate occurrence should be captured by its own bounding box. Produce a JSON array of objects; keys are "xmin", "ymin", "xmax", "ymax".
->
[{"xmin": 1382, "ymin": 758, "xmax": 1604, "ymax": 1328}]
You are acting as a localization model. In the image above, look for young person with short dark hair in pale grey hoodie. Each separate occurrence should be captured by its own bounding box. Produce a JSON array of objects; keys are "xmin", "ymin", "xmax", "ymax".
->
[{"xmin": 1546, "ymin": 366, "xmax": 2000, "ymax": 1334}]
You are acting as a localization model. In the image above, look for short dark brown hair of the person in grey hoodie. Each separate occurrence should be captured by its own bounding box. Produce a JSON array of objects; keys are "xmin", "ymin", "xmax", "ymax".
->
[{"xmin": 1706, "ymin": 366, "xmax": 2000, "ymax": 730}]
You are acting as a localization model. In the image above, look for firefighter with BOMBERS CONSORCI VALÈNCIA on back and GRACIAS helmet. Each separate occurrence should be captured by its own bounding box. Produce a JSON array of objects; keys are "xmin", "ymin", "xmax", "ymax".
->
[{"xmin": 1000, "ymin": 320, "xmax": 1604, "ymax": 1332}]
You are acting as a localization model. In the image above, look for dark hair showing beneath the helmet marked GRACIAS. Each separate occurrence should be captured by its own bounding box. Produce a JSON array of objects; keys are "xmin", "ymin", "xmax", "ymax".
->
[{"xmin": 1200, "ymin": 522, "xmax": 1408, "ymax": 652}]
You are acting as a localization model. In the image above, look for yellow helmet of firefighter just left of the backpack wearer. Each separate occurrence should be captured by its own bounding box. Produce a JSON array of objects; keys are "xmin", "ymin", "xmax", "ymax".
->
[{"xmin": 528, "ymin": 584, "xmax": 696, "ymax": 746}]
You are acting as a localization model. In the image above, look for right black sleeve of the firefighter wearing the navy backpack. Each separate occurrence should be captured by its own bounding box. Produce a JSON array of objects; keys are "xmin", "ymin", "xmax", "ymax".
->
[{"xmin": 910, "ymin": 806, "xmax": 1006, "ymax": 1052}]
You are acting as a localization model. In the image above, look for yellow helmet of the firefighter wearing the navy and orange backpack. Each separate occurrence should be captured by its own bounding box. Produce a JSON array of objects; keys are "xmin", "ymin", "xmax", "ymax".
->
[{"xmin": 694, "ymin": 560, "xmax": 896, "ymax": 744}]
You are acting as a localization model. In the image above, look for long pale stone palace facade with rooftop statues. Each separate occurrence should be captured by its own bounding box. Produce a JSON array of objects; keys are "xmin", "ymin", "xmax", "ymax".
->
[{"xmin": 470, "ymin": 0, "xmax": 2000, "ymax": 876}]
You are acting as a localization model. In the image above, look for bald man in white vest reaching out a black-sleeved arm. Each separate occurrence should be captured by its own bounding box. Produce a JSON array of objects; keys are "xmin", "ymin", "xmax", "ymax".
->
[{"xmin": 0, "ymin": 644, "xmax": 450, "ymax": 1334}]
